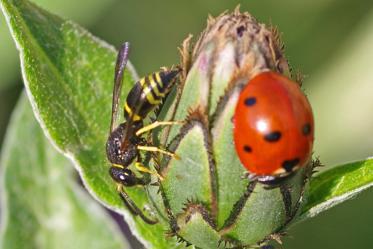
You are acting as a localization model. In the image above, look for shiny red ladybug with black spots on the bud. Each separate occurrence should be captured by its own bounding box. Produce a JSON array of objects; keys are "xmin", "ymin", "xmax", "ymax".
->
[{"xmin": 233, "ymin": 71, "xmax": 314, "ymax": 184}]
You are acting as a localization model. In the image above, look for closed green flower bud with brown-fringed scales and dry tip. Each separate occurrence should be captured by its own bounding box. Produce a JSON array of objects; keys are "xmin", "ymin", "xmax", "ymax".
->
[{"xmin": 148, "ymin": 6, "xmax": 310, "ymax": 248}]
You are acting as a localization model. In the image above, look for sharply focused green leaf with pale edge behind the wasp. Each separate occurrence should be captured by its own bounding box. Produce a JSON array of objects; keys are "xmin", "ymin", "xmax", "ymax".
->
[{"xmin": 1, "ymin": 0, "xmax": 183, "ymax": 248}]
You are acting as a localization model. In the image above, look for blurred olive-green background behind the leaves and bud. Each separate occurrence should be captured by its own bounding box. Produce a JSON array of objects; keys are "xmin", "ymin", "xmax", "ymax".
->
[{"xmin": 0, "ymin": 0, "xmax": 373, "ymax": 249}]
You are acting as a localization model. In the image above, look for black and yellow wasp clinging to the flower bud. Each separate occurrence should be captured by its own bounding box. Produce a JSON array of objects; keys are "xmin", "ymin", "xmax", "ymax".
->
[{"xmin": 106, "ymin": 42, "xmax": 180, "ymax": 224}]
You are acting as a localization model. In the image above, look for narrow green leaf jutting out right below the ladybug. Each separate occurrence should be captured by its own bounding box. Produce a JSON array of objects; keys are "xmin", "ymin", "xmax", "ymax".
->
[{"xmin": 297, "ymin": 159, "xmax": 373, "ymax": 221}]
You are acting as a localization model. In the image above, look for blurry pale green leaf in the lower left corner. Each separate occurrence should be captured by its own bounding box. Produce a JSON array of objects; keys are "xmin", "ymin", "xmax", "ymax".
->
[{"xmin": 0, "ymin": 96, "xmax": 129, "ymax": 249}]
